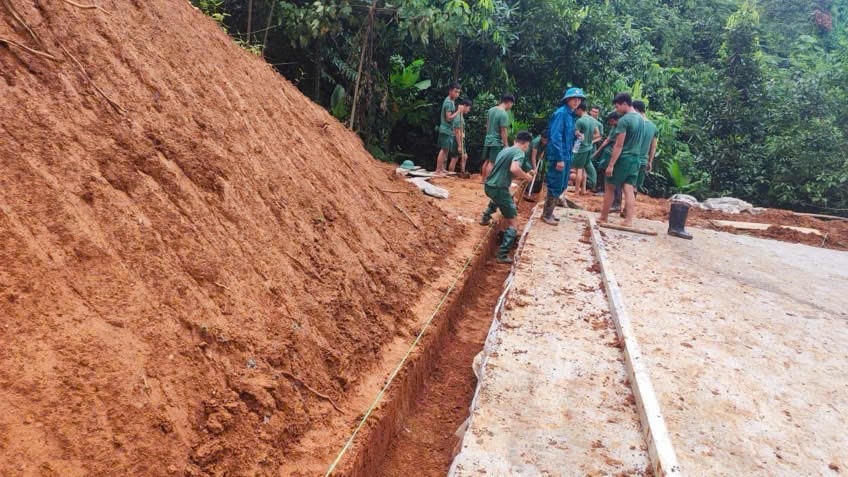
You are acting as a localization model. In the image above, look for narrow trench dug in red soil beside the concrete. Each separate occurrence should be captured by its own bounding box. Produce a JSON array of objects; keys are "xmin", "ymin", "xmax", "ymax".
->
[{"xmin": 333, "ymin": 195, "xmax": 533, "ymax": 477}]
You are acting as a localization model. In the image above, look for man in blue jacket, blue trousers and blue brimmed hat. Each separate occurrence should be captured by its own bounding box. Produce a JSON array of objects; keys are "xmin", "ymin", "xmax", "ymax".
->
[{"xmin": 542, "ymin": 88, "xmax": 586, "ymax": 225}]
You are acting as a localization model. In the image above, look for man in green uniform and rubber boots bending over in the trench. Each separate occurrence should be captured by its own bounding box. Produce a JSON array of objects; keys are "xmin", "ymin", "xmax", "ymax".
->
[{"xmin": 480, "ymin": 131, "xmax": 535, "ymax": 263}]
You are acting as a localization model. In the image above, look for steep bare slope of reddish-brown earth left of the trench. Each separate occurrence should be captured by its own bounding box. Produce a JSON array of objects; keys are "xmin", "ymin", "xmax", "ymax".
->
[{"xmin": 0, "ymin": 0, "xmax": 462, "ymax": 476}]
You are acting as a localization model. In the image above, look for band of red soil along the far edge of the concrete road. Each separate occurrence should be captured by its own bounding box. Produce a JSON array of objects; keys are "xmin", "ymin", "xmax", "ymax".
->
[{"xmin": 569, "ymin": 193, "xmax": 848, "ymax": 250}]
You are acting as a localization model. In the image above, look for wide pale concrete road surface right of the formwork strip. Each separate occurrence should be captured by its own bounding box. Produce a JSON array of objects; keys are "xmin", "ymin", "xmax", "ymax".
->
[{"xmin": 603, "ymin": 217, "xmax": 848, "ymax": 477}]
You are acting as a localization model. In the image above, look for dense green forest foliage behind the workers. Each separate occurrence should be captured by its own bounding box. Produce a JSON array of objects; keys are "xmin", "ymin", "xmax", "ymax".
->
[{"xmin": 194, "ymin": 0, "xmax": 848, "ymax": 210}]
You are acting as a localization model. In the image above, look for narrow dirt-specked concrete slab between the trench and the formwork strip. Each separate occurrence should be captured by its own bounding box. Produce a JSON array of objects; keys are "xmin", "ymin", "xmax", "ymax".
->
[{"xmin": 450, "ymin": 215, "xmax": 649, "ymax": 476}]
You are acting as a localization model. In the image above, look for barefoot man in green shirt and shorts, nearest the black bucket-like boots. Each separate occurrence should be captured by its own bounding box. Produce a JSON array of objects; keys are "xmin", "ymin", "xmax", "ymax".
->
[{"xmin": 598, "ymin": 93, "xmax": 645, "ymax": 227}]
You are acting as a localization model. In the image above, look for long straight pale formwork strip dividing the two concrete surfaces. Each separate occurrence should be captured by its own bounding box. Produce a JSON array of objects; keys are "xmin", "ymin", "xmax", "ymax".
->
[{"xmin": 585, "ymin": 213, "xmax": 683, "ymax": 476}]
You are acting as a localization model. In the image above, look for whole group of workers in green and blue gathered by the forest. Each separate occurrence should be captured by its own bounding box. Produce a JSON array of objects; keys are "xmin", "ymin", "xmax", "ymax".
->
[{"xmin": 436, "ymin": 83, "xmax": 658, "ymax": 263}]
